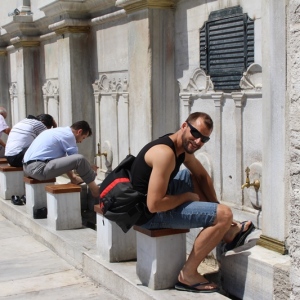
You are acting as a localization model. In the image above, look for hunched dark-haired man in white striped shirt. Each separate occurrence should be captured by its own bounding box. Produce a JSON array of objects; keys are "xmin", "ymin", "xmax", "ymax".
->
[{"xmin": 5, "ymin": 114, "xmax": 57, "ymax": 167}]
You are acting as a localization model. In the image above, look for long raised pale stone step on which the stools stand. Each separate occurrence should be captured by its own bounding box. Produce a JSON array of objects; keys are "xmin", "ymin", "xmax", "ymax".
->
[{"xmin": 0, "ymin": 198, "xmax": 229, "ymax": 300}]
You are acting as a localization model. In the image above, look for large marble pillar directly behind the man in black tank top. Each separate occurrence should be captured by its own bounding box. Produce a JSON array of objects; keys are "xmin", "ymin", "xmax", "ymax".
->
[{"xmin": 116, "ymin": 0, "xmax": 178, "ymax": 153}]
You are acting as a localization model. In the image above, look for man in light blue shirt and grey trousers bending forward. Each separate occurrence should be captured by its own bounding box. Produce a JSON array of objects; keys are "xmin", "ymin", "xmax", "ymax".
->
[{"xmin": 23, "ymin": 121, "xmax": 99, "ymax": 197}]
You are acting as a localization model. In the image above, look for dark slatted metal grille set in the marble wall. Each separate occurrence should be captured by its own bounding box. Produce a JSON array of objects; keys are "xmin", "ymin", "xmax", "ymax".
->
[{"xmin": 200, "ymin": 6, "xmax": 254, "ymax": 91}]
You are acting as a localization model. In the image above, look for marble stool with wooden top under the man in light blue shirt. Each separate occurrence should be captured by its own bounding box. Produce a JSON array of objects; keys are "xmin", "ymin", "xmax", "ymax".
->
[{"xmin": 23, "ymin": 176, "xmax": 56, "ymax": 217}]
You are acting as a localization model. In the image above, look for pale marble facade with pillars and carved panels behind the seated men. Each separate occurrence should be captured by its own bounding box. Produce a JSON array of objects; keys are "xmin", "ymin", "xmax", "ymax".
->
[{"xmin": 0, "ymin": 0, "xmax": 300, "ymax": 299}]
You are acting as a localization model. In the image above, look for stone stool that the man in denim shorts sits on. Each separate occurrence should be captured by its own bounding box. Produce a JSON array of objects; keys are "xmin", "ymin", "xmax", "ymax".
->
[{"xmin": 134, "ymin": 226, "xmax": 189, "ymax": 290}]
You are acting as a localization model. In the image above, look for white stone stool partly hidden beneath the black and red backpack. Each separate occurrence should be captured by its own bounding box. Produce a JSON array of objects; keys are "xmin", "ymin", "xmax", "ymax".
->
[{"xmin": 94, "ymin": 204, "xmax": 136, "ymax": 262}]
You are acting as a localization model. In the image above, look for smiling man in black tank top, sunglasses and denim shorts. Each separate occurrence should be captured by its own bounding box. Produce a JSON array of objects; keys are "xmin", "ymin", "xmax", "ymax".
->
[{"xmin": 131, "ymin": 112, "xmax": 254, "ymax": 293}]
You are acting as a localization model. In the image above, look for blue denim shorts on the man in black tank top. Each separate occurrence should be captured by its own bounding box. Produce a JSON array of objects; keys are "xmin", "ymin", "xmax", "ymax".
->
[{"xmin": 142, "ymin": 169, "xmax": 218, "ymax": 229}]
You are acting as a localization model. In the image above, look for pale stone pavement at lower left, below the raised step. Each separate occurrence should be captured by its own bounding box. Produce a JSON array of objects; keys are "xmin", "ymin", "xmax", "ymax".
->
[{"xmin": 0, "ymin": 215, "xmax": 121, "ymax": 300}]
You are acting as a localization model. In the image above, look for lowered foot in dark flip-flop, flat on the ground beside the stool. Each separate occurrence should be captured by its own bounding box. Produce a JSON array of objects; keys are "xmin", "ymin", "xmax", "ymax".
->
[{"xmin": 175, "ymin": 271, "xmax": 218, "ymax": 292}]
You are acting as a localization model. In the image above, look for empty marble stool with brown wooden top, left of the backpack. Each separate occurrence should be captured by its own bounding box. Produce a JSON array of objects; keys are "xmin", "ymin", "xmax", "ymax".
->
[{"xmin": 45, "ymin": 183, "xmax": 82, "ymax": 230}]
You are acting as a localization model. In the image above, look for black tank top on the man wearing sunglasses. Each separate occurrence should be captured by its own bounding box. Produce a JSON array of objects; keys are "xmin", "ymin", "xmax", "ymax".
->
[{"xmin": 131, "ymin": 134, "xmax": 185, "ymax": 194}]
